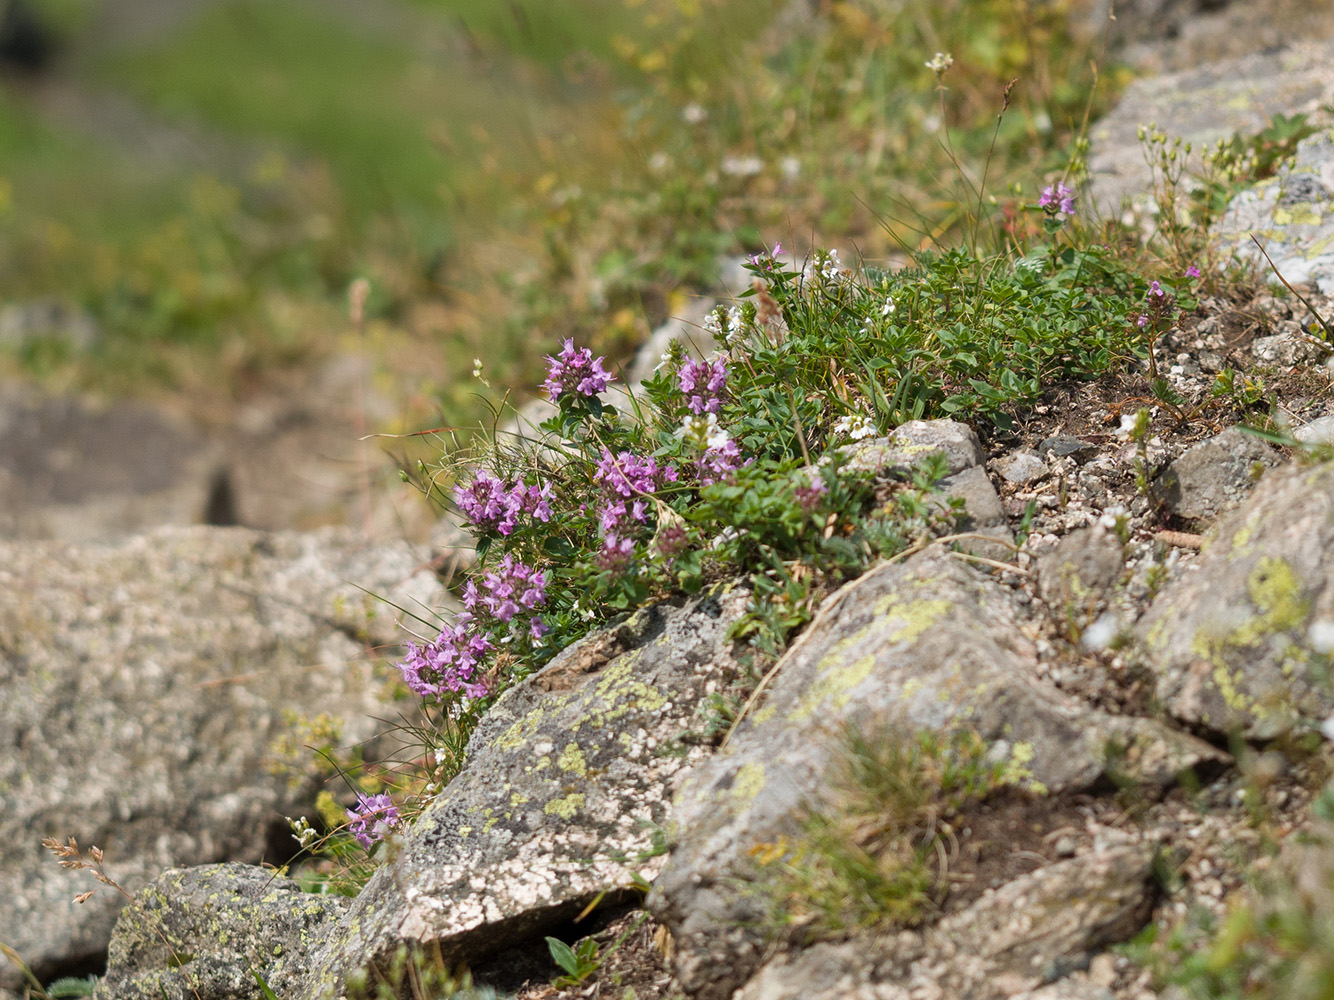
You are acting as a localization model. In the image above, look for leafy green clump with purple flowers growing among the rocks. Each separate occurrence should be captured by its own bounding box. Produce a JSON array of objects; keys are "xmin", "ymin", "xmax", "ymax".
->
[{"xmin": 320, "ymin": 216, "xmax": 1194, "ymax": 874}]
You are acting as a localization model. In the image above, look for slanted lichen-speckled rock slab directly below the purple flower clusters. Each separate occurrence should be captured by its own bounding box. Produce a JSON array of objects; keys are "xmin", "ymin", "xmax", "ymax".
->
[{"xmin": 295, "ymin": 585, "xmax": 750, "ymax": 1000}]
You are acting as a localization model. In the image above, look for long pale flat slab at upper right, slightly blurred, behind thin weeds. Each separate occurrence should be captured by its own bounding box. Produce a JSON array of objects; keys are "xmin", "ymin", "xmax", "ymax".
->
[{"xmin": 1086, "ymin": 41, "xmax": 1334, "ymax": 219}]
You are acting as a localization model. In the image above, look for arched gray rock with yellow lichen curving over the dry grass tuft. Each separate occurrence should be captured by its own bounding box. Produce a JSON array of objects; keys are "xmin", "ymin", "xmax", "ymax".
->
[{"xmin": 648, "ymin": 551, "xmax": 1218, "ymax": 1000}]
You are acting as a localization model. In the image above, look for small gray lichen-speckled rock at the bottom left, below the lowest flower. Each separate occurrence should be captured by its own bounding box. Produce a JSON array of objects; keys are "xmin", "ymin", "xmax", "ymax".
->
[{"xmin": 93, "ymin": 864, "xmax": 351, "ymax": 1000}]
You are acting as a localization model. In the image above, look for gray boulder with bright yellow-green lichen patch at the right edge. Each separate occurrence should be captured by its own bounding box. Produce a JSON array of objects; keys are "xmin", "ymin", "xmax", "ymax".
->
[{"xmin": 1135, "ymin": 463, "xmax": 1334, "ymax": 739}]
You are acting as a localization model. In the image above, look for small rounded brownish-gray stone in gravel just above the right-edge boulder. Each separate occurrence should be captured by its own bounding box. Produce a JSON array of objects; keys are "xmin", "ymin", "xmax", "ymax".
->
[{"xmin": 1151, "ymin": 427, "xmax": 1279, "ymax": 520}]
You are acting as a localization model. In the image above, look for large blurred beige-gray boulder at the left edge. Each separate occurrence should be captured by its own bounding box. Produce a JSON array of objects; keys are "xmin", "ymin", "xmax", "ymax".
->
[{"xmin": 0, "ymin": 528, "xmax": 443, "ymax": 989}]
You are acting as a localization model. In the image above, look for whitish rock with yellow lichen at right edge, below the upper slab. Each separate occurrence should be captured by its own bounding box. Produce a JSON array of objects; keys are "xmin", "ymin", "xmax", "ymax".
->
[{"xmin": 1213, "ymin": 129, "xmax": 1334, "ymax": 295}]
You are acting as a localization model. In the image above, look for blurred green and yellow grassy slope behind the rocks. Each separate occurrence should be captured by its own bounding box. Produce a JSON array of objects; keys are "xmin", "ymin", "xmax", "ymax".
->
[{"xmin": 0, "ymin": 0, "xmax": 1121, "ymax": 425}]
